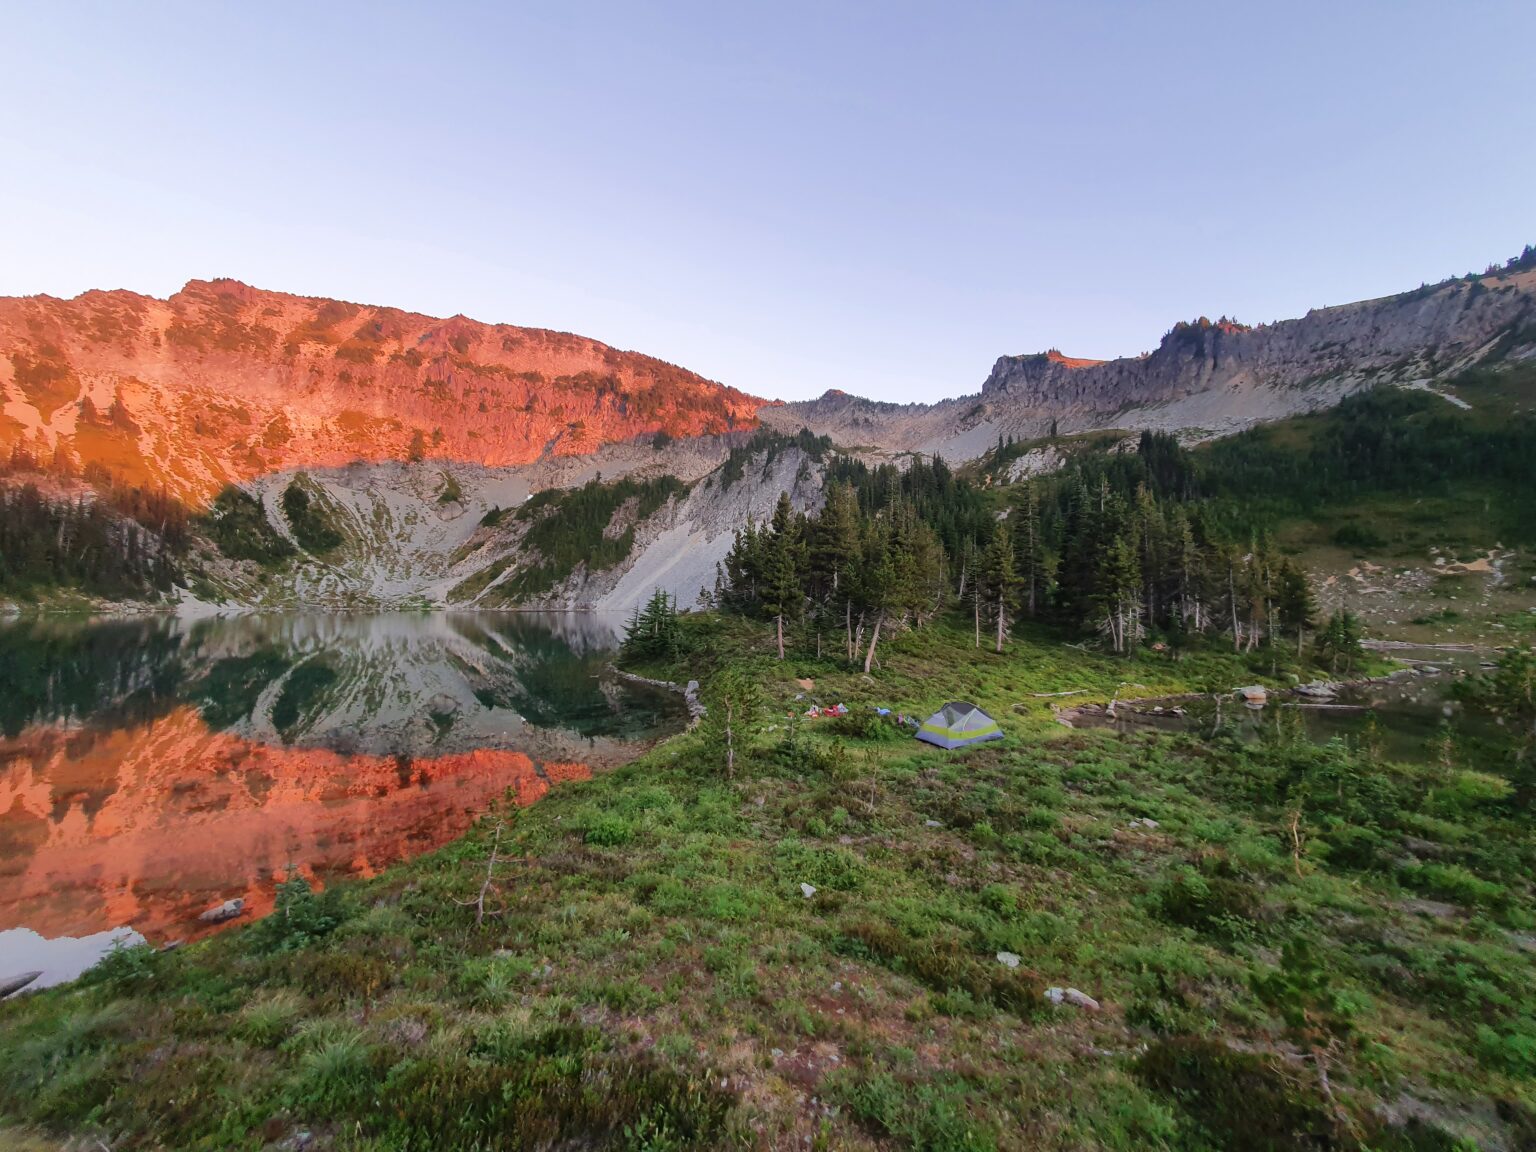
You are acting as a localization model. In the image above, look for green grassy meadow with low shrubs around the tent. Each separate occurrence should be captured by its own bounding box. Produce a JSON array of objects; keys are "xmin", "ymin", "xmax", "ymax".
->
[{"xmin": 0, "ymin": 616, "xmax": 1536, "ymax": 1152}]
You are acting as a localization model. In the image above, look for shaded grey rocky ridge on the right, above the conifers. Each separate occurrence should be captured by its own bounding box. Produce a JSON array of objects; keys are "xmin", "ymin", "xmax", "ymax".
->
[{"xmin": 762, "ymin": 261, "xmax": 1536, "ymax": 461}]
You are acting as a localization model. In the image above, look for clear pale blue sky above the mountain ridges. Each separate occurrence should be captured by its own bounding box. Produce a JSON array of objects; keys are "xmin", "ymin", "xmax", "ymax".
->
[{"xmin": 0, "ymin": 0, "xmax": 1536, "ymax": 399}]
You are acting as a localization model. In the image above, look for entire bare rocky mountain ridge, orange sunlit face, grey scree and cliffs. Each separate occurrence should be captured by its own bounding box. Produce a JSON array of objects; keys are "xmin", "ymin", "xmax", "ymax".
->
[{"xmin": 0, "ymin": 249, "xmax": 1536, "ymax": 611}]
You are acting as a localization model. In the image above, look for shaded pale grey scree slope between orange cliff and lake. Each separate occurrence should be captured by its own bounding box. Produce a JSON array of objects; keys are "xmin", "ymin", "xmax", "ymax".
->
[{"xmin": 187, "ymin": 439, "xmax": 822, "ymax": 613}]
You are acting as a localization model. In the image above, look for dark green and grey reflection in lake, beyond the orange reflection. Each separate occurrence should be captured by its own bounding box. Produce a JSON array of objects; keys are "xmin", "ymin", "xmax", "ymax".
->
[{"xmin": 0, "ymin": 613, "xmax": 677, "ymax": 756}]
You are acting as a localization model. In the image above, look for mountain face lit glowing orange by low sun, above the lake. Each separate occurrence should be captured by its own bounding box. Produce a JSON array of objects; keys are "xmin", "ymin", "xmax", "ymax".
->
[{"xmin": 0, "ymin": 280, "xmax": 763, "ymax": 501}]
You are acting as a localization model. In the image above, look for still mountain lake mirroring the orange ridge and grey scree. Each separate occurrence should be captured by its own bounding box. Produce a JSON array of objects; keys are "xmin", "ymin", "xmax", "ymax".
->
[{"xmin": 0, "ymin": 613, "xmax": 685, "ymax": 986}]
